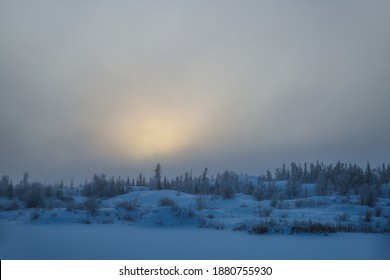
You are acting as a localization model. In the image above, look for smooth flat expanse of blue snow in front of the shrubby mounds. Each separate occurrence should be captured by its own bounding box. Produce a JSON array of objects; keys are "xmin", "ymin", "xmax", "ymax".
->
[{"xmin": 0, "ymin": 222, "xmax": 390, "ymax": 260}]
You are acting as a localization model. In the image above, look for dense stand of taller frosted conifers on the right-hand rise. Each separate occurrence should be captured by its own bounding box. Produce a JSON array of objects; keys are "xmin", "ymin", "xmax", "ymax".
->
[{"xmin": 247, "ymin": 162, "xmax": 390, "ymax": 207}]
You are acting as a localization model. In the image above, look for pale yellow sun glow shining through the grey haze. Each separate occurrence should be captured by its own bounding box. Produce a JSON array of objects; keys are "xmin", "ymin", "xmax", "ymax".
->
[{"xmin": 105, "ymin": 106, "xmax": 205, "ymax": 160}]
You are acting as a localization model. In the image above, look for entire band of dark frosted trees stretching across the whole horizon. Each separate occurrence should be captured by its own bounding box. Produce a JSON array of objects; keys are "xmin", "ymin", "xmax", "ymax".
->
[{"xmin": 0, "ymin": 162, "xmax": 390, "ymax": 208}]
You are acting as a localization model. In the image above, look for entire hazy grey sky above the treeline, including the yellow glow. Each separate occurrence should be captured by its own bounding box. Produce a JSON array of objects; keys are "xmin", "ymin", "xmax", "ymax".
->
[{"xmin": 0, "ymin": 0, "xmax": 390, "ymax": 181}]
